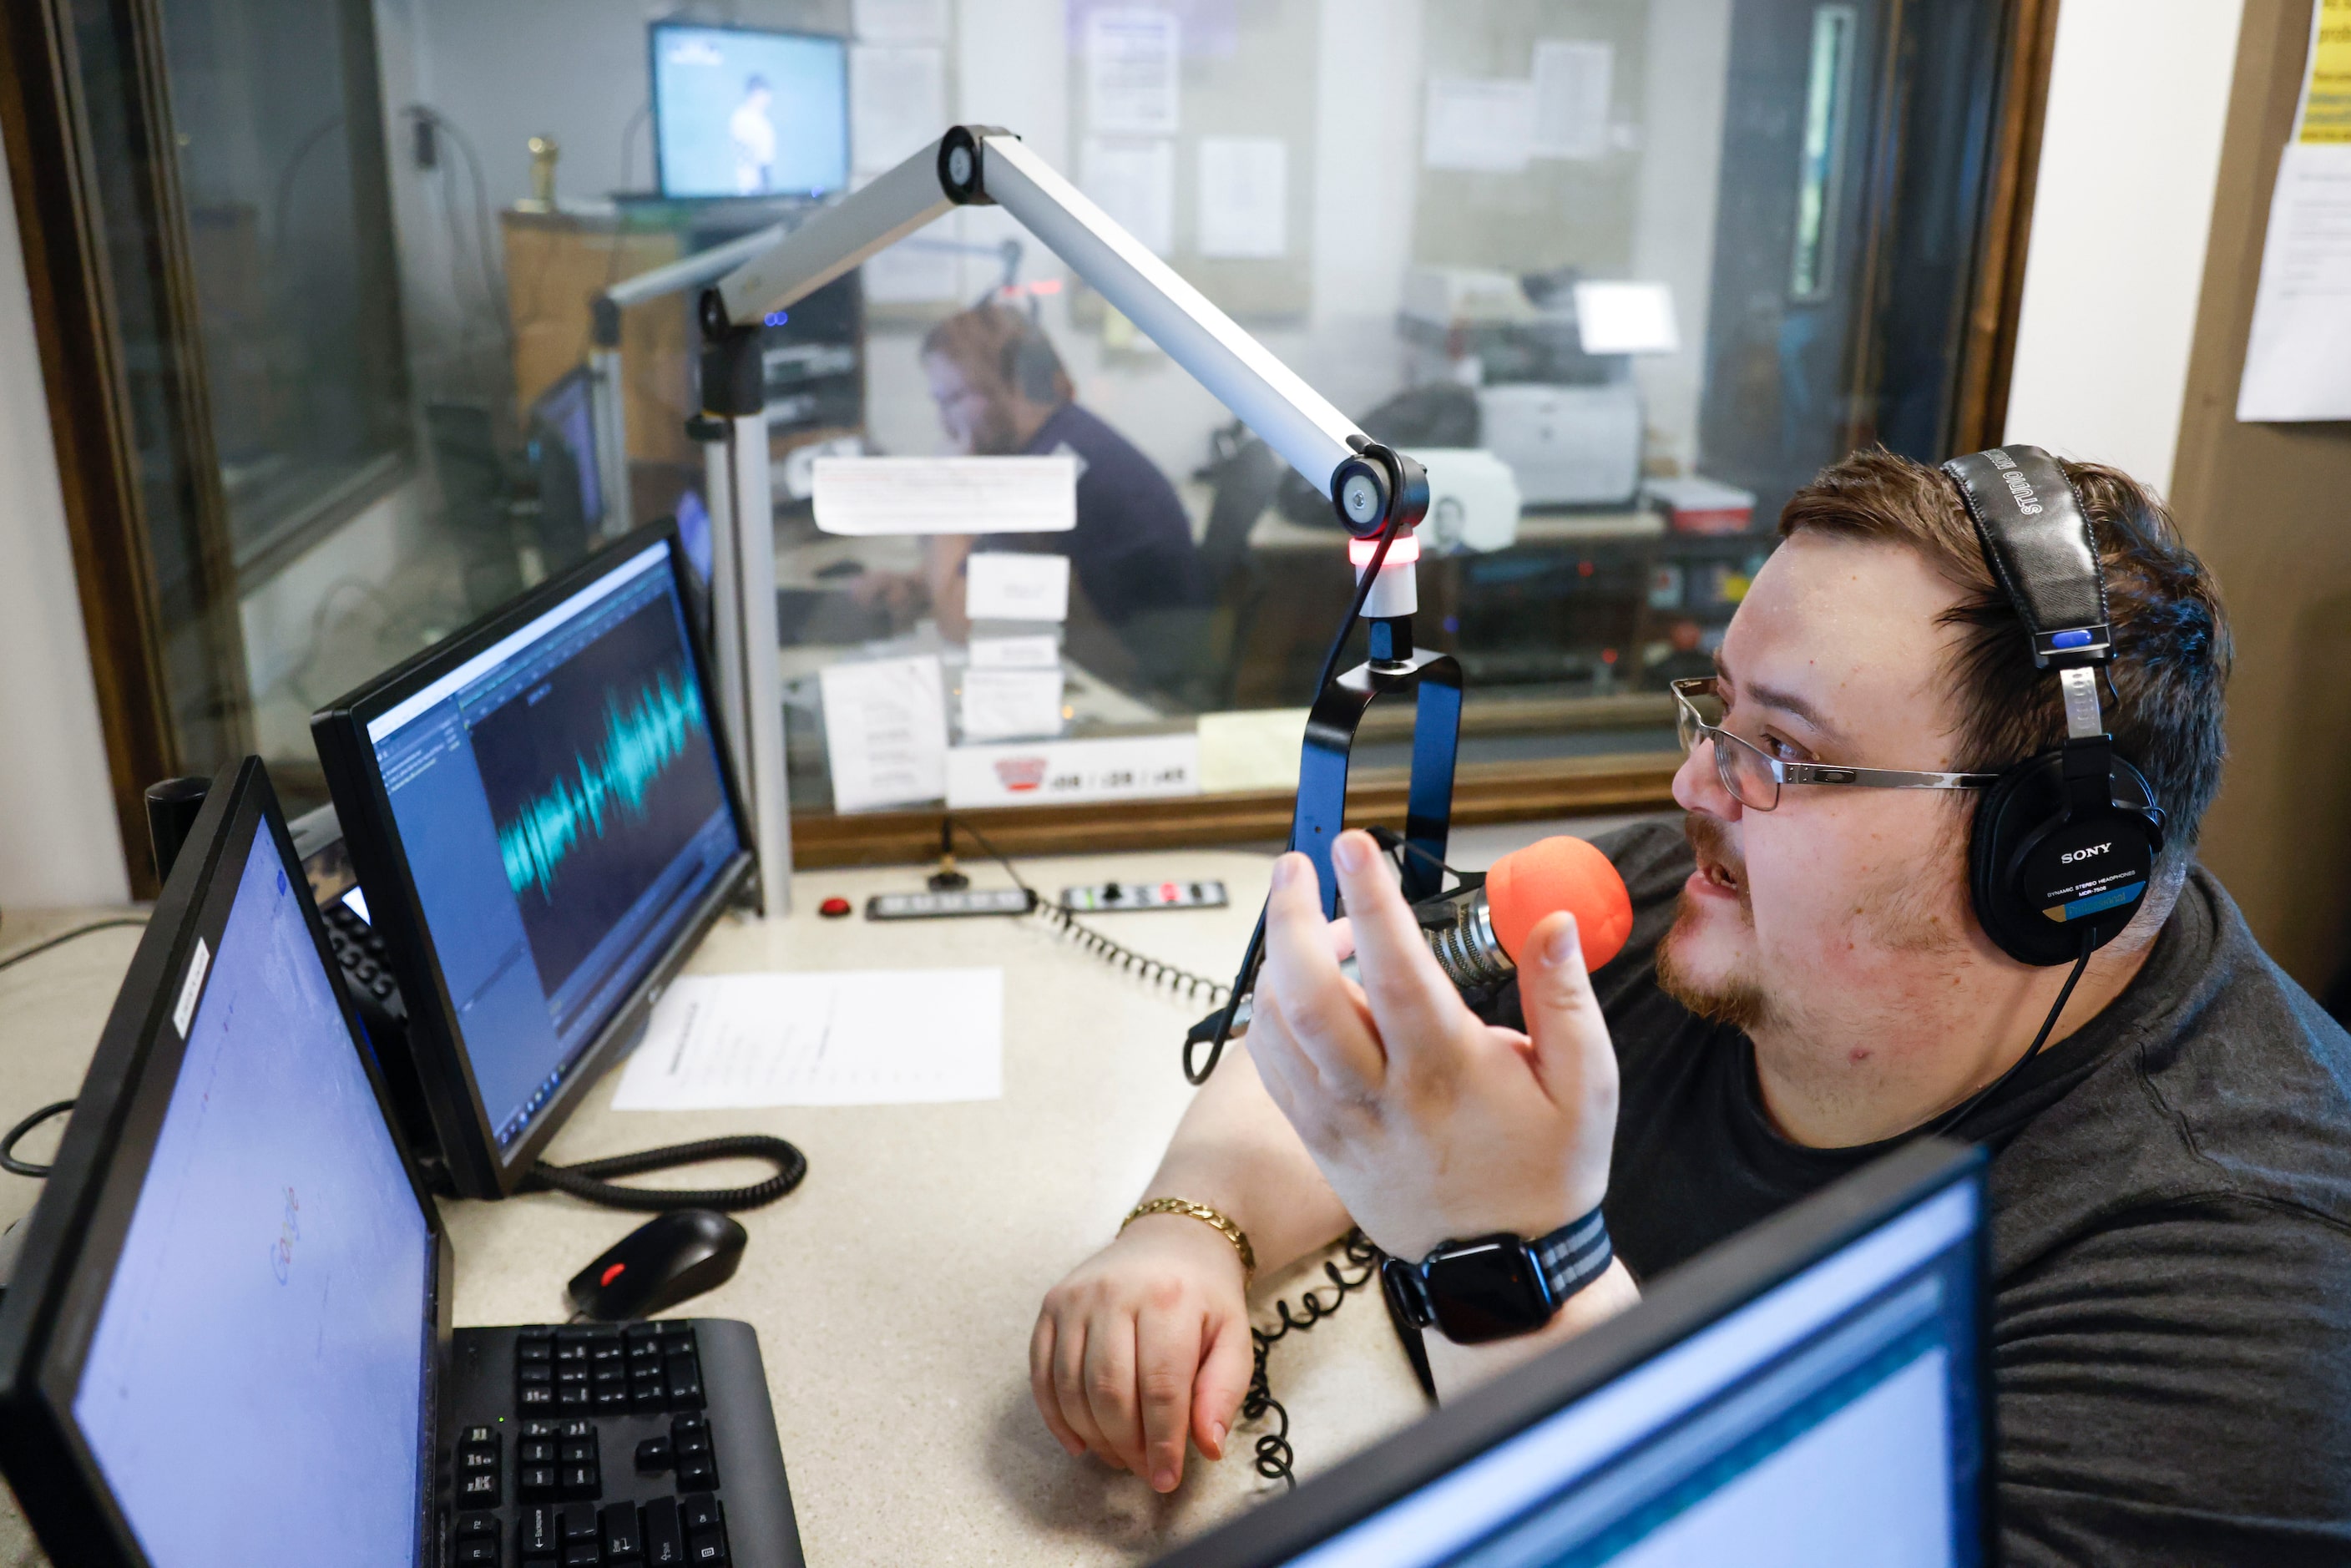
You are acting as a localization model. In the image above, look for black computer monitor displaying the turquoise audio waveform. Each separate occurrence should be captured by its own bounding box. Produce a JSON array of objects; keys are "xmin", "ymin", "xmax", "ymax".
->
[{"xmin": 311, "ymin": 522, "xmax": 752, "ymax": 1196}]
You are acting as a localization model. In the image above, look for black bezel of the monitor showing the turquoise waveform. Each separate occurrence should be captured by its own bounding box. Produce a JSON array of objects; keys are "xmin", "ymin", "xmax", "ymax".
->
[{"xmin": 311, "ymin": 519, "xmax": 755, "ymax": 1199}]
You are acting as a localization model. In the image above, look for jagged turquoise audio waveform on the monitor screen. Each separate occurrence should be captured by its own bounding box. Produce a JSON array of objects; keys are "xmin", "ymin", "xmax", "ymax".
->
[{"xmin": 498, "ymin": 670, "xmax": 705, "ymax": 898}]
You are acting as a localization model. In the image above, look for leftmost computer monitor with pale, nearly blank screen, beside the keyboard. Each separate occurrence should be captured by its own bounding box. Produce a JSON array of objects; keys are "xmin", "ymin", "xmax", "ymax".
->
[{"xmin": 0, "ymin": 759, "xmax": 449, "ymax": 1568}]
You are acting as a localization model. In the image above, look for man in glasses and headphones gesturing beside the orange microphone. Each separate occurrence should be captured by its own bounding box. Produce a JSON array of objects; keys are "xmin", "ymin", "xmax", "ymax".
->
[{"xmin": 1029, "ymin": 447, "xmax": 2351, "ymax": 1563}]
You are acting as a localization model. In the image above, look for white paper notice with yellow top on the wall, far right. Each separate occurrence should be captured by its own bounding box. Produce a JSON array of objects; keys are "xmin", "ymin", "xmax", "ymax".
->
[{"xmin": 2236, "ymin": 0, "xmax": 2351, "ymax": 423}]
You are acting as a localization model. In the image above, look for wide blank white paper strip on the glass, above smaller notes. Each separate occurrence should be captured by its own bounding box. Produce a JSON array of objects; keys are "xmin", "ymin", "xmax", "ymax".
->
[{"xmin": 809, "ymin": 456, "xmax": 1077, "ymax": 539}]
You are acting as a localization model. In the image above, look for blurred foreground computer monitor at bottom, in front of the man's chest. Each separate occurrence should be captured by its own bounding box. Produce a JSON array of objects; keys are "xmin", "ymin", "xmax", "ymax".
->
[{"xmin": 1161, "ymin": 1141, "xmax": 1994, "ymax": 1568}]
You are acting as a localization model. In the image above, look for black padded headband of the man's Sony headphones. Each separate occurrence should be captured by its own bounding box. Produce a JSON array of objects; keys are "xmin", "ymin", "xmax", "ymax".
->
[{"xmin": 1942, "ymin": 447, "xmax": 2114, "ymax": 670}]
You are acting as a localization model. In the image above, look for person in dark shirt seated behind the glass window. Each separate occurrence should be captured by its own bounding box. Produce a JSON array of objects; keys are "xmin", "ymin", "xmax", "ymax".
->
[{"xmin": 865, "ymin": 306, "xmax": 1208, "ymax": 689}]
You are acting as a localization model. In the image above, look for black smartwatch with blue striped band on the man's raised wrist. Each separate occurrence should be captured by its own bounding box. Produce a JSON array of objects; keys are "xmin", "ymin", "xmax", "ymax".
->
[{"xmin": 1380, "ymin": 1208, "xmax": 1615, "ymax": 1345}]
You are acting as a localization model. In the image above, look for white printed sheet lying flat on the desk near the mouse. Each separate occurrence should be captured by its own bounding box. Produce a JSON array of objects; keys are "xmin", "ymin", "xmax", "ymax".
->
[{"xmin": 611, "ymin": 969, "xmax": 1004, "ymax": 1110}]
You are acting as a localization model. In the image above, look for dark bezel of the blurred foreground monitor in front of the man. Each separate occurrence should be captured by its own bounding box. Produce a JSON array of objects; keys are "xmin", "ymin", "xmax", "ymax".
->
[{"xmin": 1155, "ymin": 1138, "xmax": 1999, "ymax": 1568}]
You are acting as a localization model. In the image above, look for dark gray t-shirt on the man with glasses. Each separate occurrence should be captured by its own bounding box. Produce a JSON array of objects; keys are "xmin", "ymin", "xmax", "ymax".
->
[{"xmin": 1495, "ymin": 825, "xmax": 2351, "ymax": 1565}]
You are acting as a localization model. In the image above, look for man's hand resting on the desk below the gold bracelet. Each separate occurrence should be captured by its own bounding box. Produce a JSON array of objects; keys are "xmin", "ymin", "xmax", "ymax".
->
[{"xmin": 1029, "ymin": 1213, "xmax": 1251, "ymax": 1493}]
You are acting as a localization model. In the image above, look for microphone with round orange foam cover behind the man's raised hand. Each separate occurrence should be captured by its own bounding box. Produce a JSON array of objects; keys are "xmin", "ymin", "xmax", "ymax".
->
[{"xmin": 1192, "ymin": 835, "xmax": 1631, "ymax": 1039}]
